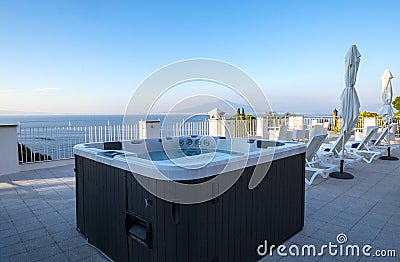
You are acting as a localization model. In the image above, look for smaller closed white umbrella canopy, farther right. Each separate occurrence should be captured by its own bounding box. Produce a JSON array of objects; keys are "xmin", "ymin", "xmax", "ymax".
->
[{"xmin": 378, "ymin": 69, "xmax": 394, "ymax": 124}]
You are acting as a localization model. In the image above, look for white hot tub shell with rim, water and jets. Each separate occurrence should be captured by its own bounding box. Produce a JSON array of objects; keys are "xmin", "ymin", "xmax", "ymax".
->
[{"xmin": 74, "ymin": 136, "xmax": 305, "ymax": 180}]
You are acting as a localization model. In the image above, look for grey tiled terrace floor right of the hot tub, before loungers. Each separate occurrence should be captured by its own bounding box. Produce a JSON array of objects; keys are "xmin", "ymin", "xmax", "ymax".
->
[{"xmin": 267, "ymin": 149, "xmax": 400, "ymax": 261}]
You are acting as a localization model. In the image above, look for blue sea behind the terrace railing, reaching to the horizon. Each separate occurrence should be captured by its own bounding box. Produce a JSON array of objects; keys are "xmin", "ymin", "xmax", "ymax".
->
[{"xmin": 0, "ymin": 114, "xmax": 330, "ymax": 160}]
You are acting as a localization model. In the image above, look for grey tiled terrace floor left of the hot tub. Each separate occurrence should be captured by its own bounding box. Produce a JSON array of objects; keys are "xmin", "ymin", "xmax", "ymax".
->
[{"xmin": 0, "ymin": 165, "xmax": 107, "ymax": 261}]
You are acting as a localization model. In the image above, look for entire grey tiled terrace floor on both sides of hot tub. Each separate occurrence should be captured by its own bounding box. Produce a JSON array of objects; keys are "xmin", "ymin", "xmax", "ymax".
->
[{"xmin": 0, "ymin": 150, "xmax": 400, "ymax": 261}]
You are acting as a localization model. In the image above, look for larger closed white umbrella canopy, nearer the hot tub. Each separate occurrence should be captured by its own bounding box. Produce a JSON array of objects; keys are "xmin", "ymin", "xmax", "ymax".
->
[{"xmin": 340, "ymin": 45, "xmax": 361, "ymax": 132}]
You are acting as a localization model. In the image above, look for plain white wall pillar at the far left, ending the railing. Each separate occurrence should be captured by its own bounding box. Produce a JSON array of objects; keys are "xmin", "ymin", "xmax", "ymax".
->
[{"xmin": 0, "ymin": 124, "xmax": 19, "ymax": 175}]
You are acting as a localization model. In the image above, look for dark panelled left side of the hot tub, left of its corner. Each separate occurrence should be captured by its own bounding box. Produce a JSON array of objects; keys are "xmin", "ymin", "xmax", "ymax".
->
[{"xmin": 75, "ymin": 156, "xmax": 128, "ymax": 261}]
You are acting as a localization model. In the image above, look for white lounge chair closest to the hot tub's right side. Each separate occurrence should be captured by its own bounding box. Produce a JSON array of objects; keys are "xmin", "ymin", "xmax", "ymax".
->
[{"xmin": 305, "ymin": 134, "xmax": 338, "ymax": 185}]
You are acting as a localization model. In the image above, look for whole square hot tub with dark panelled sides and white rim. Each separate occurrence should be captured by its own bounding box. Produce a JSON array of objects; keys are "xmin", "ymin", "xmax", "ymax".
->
[{"xmin": 74, "ymin": 136, "xmax": 305, "ymax": 261}]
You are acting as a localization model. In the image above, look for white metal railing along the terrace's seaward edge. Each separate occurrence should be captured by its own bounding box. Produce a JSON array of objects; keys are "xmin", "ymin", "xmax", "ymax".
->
[{"xmin": 17, "ymin": 116, "xmax": 400, "ymax": 164}]
